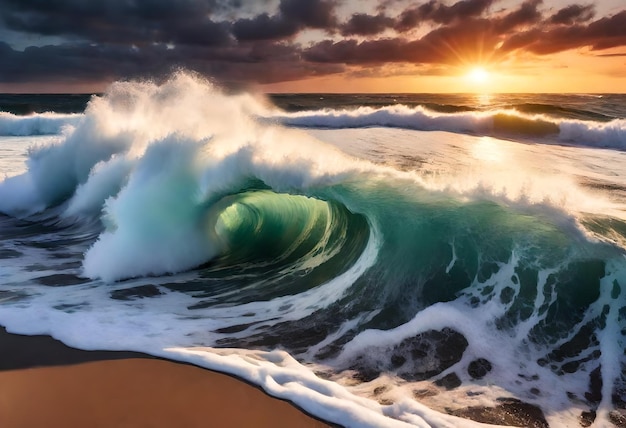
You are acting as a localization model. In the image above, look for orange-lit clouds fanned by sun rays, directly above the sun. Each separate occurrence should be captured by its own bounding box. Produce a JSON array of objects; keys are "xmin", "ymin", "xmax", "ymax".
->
[{"xmin": 304, "ymin": 0, "xmax": 626, "ymax": 65}]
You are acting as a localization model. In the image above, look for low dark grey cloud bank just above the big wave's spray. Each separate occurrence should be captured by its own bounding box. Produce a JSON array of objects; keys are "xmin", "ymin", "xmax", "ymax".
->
[{"xmin": 0, "ymin": 42, "xmax": 345, "ymax": 83}]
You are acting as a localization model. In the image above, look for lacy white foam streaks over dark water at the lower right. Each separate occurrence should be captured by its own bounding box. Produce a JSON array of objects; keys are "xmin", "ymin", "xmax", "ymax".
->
[{"xmin": 331, "ymin": 249, "xmax": 623, "ymax": 427}]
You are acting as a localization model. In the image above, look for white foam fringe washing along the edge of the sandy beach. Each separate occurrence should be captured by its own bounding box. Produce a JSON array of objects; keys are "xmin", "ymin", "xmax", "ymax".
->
[{"xmin": 0, "ymin": 278, "xmax": 481, "ymax": 427}]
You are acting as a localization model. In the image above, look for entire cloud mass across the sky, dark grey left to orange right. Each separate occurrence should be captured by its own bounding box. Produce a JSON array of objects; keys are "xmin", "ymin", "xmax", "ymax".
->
[{"xmin": 0, "ymin": 0, "xmax": 626, "ymax": 88}]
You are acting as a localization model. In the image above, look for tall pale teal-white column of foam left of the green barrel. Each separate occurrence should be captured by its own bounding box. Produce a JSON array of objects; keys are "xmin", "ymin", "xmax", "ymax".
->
[{"xmin": 83, "ymin": 140, "xmax": 219, "ymax": 282}]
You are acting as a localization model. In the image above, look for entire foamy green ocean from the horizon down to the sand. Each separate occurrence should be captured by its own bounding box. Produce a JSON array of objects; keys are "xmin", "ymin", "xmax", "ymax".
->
[{"xmin": 0, "ymin": 73, "xmax": 626, "ymax": 427}]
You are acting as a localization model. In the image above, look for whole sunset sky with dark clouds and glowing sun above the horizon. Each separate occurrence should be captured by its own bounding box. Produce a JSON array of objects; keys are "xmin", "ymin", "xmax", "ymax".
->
[{"xmin": 0, "ymin": 0, "xmax": 626, "ymax": 93}]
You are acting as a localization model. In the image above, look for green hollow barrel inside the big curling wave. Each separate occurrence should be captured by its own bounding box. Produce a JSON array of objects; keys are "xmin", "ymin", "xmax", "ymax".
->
[{"xmin": 194, "ymin": 190, "xmax": 370, "ymax": 303}]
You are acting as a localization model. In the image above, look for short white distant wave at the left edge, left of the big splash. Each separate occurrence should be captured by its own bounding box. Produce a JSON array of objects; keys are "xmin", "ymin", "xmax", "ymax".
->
[{"xmin": 0, "ymin": 112, "xmax": 83, "ymax": 137}]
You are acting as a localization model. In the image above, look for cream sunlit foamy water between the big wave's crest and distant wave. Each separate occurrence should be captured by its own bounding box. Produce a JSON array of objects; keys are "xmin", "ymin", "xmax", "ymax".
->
[{"xmin": 308, "ymin": 128, "xmax": 626, "ymax": 222}]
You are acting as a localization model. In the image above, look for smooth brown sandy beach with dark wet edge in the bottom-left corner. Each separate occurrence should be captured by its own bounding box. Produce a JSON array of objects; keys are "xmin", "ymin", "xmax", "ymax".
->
[{"xmin": 0, "ymin": 329, "xmax": 328, "ymax": 428}]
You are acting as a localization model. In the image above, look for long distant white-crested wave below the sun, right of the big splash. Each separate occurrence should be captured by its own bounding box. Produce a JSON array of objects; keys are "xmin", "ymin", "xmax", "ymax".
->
[{"xmin": 269, "ymin": 105, "xmax": 626, "ymax": 149}]
